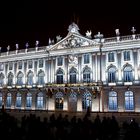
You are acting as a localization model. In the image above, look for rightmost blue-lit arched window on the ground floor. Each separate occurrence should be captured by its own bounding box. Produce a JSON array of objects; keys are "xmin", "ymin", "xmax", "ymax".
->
[{"xmin": 125, "ymin": 91, "xmax": 134, "ymax": 110}]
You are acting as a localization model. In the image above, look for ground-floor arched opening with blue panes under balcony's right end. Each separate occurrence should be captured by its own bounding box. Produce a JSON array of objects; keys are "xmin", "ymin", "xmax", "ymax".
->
[{"xmin": 82, "ymin": 91, "xmax": 92, "ymax": 109}]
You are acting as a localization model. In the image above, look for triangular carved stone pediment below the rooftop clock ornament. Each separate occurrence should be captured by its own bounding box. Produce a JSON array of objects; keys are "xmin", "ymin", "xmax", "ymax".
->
[{"xmin": 48, "ymin": 33, "xmax": 97, "ymax": 50}]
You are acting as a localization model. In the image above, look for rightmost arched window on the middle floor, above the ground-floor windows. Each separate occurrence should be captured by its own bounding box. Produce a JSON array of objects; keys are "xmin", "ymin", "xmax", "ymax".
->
[{"xmin": 123, "ymin": 66, "xmax": 133, "ymax": 82}]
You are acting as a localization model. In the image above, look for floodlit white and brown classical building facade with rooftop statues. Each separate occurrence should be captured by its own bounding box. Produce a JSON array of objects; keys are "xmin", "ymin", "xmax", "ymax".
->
[{"xmin": 0, "ymin": 23, "xmax": 140, "ymax": 112}]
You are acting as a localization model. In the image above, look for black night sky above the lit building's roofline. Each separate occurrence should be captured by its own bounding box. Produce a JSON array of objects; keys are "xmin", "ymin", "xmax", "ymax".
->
[{"xmin": 0, "ymin": 0, "xmax": 140, "ymax": 51}]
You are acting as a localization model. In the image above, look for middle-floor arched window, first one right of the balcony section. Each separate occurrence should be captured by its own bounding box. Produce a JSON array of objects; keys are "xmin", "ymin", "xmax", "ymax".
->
[{"xmin": 108, "ymin": 67, "xmax": 116, "ymax": 83}]
